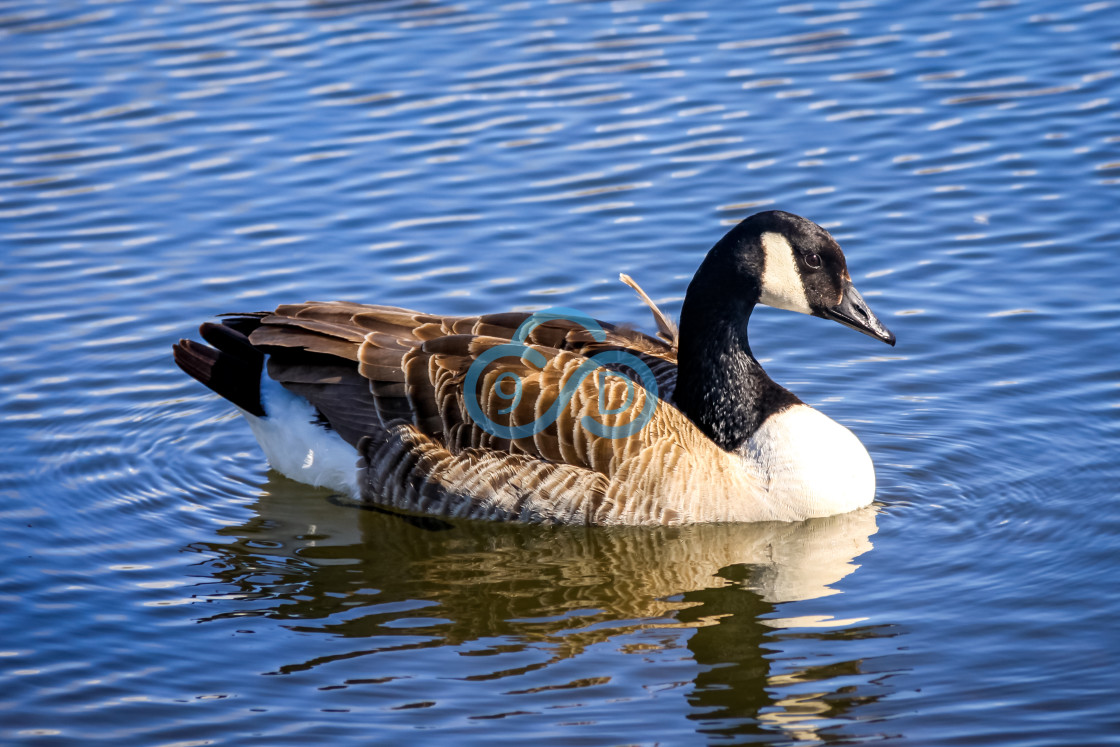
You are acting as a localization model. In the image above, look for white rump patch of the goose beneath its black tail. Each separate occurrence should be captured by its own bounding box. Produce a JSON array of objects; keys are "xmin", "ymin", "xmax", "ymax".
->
[{"xmin": 241, "ymin": 372, "xmax": 358, "ymax": 498}]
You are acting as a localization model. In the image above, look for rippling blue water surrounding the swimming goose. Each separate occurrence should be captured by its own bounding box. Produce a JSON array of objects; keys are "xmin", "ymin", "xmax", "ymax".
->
[{"xmin": 0, "ymin": 0, "xmax": 1120, "ymax": 746}]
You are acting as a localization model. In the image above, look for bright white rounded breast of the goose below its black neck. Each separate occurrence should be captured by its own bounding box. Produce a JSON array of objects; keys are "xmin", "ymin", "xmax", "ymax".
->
[{"xmin": 744, "ymin": 404, "xmax": 875, "ymax": 519}]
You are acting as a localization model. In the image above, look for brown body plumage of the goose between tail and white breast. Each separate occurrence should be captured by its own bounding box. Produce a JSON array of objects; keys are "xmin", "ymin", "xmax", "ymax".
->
[{"xmin": 228, "ymin": 291, "xmax": 761, "ymax": 524}]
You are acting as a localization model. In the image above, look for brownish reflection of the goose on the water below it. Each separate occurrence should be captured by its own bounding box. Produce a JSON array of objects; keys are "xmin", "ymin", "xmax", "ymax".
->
[{"xmin": 193, "ymin": 476, "xmax": 891, "ymax": 737}]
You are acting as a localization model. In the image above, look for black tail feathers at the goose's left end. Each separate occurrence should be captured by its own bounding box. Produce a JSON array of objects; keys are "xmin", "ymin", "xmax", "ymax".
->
[{"xmin": 172, "ymin": 323, "xmax": 265, "ymax": 417}]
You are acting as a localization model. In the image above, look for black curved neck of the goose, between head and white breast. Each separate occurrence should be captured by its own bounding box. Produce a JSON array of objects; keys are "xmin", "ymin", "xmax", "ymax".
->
[{"xmin": 673, "ymin": 256, "xmax": 801, "ymax": 451}]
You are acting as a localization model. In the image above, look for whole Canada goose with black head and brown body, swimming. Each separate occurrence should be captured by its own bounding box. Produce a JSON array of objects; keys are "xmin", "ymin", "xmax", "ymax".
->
[{"xmin": 175, "ymin": 211, "xmax": 895, "ymax": 524}]
